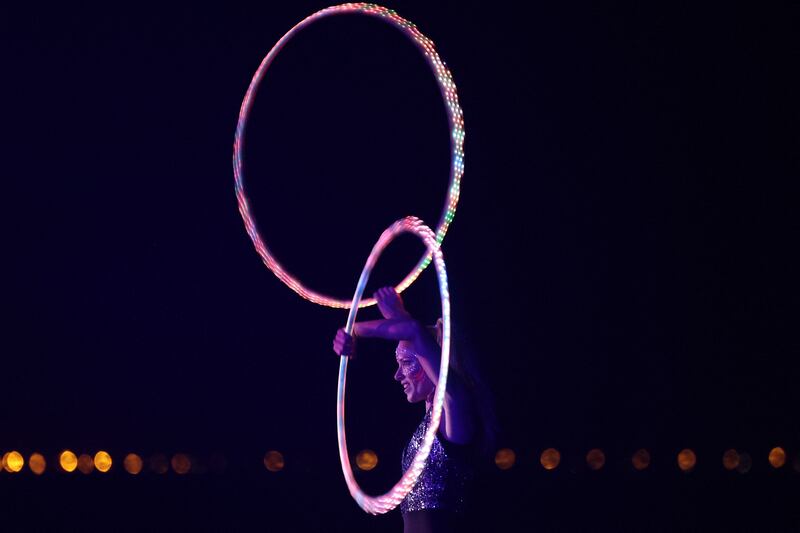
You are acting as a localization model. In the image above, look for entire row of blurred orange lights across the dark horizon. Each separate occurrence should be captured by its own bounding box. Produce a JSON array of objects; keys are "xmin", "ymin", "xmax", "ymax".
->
[{"xmin": 0, "ymin": 447, "xmax": 800, "ymax": 475}]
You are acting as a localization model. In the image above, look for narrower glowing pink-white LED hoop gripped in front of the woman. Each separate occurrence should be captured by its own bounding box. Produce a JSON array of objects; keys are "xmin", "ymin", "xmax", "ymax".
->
[{"xmin": 336, "ymin": 217, "xmax": 450, "ymax": 514}]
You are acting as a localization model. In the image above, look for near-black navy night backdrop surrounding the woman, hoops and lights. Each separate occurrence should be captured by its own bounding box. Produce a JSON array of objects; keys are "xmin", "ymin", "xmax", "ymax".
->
[{"xmin": 0, "ymin": 2, "xmax": 800, "ymax": 531}]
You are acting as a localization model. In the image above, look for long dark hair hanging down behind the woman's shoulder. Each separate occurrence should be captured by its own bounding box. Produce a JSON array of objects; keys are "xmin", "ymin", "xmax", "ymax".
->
[{"xmin": 429, "ymin": 318, "xmax": 499, "ymax": 456}]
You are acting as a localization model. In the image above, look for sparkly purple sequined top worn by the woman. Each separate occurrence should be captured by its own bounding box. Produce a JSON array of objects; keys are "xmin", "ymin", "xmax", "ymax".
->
[{"xmin": 400, "ymin": 409, "xmax": 473, "ymax": 513}]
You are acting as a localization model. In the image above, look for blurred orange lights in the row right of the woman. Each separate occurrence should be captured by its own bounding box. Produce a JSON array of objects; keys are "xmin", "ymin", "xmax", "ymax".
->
[{"xmin": 494, "ymin": 447, "xmax": 800, "ymax": 474}]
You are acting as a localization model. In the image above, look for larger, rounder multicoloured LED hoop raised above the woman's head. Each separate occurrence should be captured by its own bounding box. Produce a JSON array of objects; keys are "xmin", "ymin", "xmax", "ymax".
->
[{"xmin": 233, "ymin": 3, "xmax": 464, "ymax": 309}]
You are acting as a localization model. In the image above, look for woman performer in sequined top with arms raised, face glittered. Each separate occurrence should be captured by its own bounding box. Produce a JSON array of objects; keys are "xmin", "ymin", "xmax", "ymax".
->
[{"xmin": 333, "ymin": 287, "xmax": 494, "ymax": 533}]
